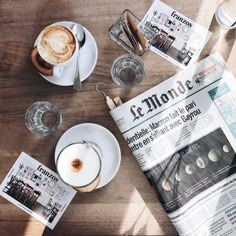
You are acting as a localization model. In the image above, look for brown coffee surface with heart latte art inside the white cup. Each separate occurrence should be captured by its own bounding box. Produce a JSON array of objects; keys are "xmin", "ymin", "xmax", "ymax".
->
[{"xmin": 37, "ymin": 25, "xmax": 76, "ymax": 65}]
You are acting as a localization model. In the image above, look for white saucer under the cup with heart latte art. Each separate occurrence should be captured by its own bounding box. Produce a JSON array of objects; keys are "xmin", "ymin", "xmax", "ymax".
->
[{"xmin": 34, "ymin": 21, "xmax": 98, "ymax": 86}]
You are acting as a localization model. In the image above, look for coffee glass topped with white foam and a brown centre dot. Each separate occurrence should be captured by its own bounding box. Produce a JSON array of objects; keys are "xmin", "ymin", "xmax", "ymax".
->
[{"xmin": 56, "ymin": 141, "xmax": 102, "ymax": 192}]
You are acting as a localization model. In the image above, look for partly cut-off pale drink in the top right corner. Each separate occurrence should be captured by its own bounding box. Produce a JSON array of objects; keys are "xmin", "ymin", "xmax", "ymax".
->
[{"xmin": 215, "ymin": 0, "xmax": 236, "ymax": 29}]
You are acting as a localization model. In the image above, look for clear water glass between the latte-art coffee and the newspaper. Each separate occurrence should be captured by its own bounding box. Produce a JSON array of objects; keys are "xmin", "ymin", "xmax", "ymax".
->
[{"xmin": 111, "ymin": 54, "xmax": 144, "ymax": 88}]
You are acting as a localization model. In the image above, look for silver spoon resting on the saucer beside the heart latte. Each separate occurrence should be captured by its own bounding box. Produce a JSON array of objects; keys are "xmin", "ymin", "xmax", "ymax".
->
[{"xmin": 71, "ymin": 24, "xmax": 86, "ymax": 91}]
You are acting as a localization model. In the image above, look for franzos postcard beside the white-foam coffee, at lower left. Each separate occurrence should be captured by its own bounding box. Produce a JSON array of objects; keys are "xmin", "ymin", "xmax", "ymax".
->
[{"xmin": 0, "ymin": 152, "xmax": 76, "ymax": 229}]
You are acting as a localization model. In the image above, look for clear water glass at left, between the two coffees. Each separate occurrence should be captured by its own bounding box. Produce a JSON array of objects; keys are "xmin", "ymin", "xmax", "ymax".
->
[{"xmin": 25, "ymin": 101, "xmax": 62, "ymax": 136}]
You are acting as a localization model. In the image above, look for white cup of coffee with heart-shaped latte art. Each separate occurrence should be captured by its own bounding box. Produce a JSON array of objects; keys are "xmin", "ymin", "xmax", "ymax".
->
[{"xmin": 31, "ymin": 24, "xmax": 79, "ymax": 77}]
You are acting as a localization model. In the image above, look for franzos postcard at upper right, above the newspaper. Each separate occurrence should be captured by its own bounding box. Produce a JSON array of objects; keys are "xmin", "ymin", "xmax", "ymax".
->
[{"xmin": 142, "ymin": 0, "xmax": 211, "ymax": 69}]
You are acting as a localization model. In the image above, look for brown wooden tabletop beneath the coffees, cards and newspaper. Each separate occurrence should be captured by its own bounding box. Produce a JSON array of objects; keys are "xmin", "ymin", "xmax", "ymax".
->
[{"xmin": 0, "ymin": 0, "xmax": 236, "ymax": 235}]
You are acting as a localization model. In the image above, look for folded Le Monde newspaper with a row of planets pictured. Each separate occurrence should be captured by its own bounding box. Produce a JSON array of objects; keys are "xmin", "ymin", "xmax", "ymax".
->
[{"xmin": 110, "ymin": 53, "xmax": 236, "ymax": 236}]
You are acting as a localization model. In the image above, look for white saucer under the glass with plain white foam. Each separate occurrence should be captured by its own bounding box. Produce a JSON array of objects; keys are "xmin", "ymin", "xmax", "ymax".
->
[{"xmin": 54, "ymin": 123, "xmax": 121, "ymax": 189}]
